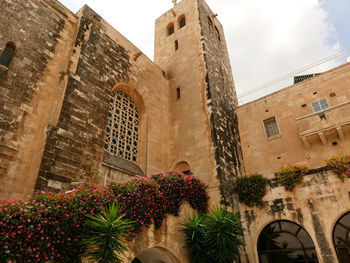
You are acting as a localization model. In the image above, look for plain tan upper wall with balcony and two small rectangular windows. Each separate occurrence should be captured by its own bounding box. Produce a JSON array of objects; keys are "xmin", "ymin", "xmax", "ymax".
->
[{"xmin": 237, "ymin": 63, "xmax": 350, "ymax": 176}]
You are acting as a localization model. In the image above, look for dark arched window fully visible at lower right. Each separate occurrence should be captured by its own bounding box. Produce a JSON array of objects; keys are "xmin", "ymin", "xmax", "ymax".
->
[{"xmin": 258, "ymin": 220, "xmax": 318, "ymax": 263}]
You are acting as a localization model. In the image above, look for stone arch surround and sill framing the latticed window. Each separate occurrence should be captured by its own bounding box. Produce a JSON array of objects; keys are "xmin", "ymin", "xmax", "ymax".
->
[{"xmin": 103, "ymin": 83, "xmax": 147, "ymax": 178}]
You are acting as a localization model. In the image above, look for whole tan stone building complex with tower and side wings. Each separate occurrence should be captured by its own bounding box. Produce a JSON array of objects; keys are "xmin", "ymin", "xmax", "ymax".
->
[{"xmin": 0, "ymin": 0, "xmax": 350, "ymax": 263}]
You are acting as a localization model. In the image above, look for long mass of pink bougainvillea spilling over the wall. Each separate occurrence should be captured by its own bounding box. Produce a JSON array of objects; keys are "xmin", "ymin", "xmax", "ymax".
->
[{"xmin": 0, "ymin": 172, "xmax": 208, "ymax": 262}]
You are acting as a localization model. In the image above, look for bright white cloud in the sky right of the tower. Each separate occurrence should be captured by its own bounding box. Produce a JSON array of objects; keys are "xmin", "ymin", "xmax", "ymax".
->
[{"xmin": 208, "ymin": 0, "xmax": 339, "ymax": 102}]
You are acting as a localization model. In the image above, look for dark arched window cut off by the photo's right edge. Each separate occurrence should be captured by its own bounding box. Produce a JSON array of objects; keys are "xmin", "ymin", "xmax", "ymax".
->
[{"xmin": 333, "ymin": 213, "xmax": 350, "ymax": 263}]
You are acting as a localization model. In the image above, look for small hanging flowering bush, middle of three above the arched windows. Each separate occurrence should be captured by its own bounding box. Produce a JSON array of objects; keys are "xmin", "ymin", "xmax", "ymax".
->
[{"xmin": 276, "ymin": 165, "xmax": 309, "ymax": 191}]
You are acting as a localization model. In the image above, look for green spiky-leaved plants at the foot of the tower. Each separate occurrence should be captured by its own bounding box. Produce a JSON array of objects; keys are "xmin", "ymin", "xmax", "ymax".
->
[{"xmin": 180, "ymin": 207, "xmax": 244, "ymax": 263}]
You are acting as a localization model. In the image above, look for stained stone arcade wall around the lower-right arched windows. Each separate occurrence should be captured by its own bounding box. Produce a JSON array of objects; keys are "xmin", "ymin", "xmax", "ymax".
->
[{"xmin": 241, "ymin": 170, "xmax": 350, "ymax": 263}]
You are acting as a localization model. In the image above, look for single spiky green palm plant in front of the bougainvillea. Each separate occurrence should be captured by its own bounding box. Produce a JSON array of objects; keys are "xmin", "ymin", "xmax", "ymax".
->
[{"xmin": 84, "ymin": 203, "xmax": 132, "ymax": 263}]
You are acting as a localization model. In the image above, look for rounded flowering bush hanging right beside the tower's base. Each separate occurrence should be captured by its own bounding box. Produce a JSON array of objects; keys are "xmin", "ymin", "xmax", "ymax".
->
[{"xmin": 234, "ymin": 174, "xmax": 267, "ymax": 207}]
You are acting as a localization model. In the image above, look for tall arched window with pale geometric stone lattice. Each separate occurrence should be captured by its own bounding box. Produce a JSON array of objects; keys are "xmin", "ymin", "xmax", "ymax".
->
[{"xmin": 104, "ymin": 91, "xmax": 140, "ymax": 163}]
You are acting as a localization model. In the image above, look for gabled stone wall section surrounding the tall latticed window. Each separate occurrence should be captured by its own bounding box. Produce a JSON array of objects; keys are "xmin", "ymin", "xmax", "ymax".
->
[{"xmin": 36, "ymin": 6, "xmax": 168, "ymax": 190}]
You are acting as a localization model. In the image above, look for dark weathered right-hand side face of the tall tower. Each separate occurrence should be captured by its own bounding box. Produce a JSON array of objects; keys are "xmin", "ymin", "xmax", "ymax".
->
[{"xmin": 198, "ymin": 0, "xmax": 244, "ymax": 206}]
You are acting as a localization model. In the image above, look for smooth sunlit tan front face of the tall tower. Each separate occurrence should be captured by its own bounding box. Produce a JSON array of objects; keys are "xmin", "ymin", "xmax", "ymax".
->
[{"xmin": 154, "ymin": 0, "xmax": 219, "ymax": 203}]
